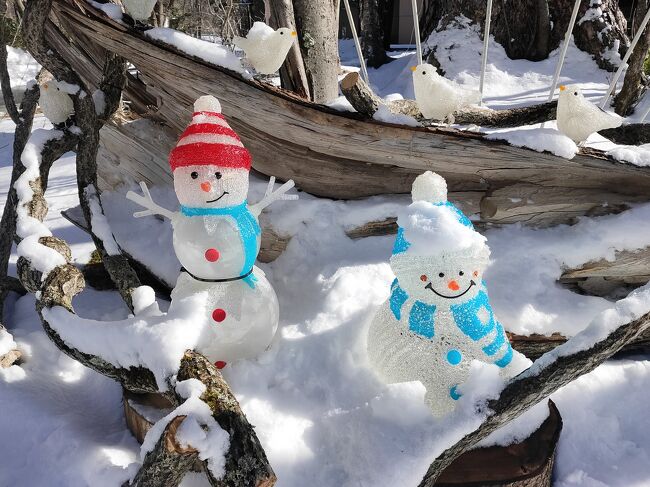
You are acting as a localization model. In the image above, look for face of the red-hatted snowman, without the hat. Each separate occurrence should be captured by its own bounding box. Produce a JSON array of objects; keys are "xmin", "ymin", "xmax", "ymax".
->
[{"xmin": 174, "ymin": 164, "xmax": 248, "ymax": 208}]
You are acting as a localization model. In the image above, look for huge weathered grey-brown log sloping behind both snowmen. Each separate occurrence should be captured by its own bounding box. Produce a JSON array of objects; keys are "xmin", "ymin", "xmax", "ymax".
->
[{"xmin": 43, "ymin": 0, "xmax": 650, "ymax": 227}]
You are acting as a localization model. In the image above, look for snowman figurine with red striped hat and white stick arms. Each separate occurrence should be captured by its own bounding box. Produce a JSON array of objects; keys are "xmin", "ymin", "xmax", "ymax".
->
[{"xmin": 126, "ymin": 96, "xmax": 297, "ymax": 368}]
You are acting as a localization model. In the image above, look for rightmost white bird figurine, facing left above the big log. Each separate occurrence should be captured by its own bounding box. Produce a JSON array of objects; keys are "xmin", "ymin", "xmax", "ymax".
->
[{"xmin": 557, "ymin": 85, "xmax": 623, "ymax": 144}]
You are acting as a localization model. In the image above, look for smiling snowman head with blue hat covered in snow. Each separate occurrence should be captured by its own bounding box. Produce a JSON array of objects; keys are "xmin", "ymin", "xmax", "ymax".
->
[{"xmin": 390, "ymin": 171, "xmax": 490, "ymax": 306}]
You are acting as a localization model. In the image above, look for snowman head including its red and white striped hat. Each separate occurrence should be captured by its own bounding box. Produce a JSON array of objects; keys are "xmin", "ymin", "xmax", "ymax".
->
[{"xmin": 169, "ymin": 96, "xmax": 251, "ymax": 208}]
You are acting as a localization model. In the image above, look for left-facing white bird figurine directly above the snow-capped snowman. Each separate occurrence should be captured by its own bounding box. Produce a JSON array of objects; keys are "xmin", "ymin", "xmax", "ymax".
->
[{"xmin": 411, "ymin": 63, "xmax": 481, "ymax": 123}]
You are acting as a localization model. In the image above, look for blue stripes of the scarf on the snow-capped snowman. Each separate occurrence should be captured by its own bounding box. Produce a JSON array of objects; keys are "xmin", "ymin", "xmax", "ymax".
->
[{"xmin": 389, "ymin": 279, "xmax": 513, "ymax": 367}]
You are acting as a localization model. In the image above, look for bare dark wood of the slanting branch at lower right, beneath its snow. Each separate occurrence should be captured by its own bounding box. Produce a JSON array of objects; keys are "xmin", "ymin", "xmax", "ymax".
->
[{"xmin": 420, "ymin": 313, "xmax": 650, "ymax": 487}]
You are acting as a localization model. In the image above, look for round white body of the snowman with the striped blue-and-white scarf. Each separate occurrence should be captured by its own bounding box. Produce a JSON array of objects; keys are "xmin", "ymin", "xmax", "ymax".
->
[{"xmin": 368, "ymin": 283, "xmax": 512, "ymax": 416}]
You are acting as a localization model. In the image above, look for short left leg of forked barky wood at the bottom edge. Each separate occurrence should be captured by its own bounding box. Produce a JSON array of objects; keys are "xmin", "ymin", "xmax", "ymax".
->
[{"xmin": 123, "ymin": 416, "xmax": 198, "ymax": 487}]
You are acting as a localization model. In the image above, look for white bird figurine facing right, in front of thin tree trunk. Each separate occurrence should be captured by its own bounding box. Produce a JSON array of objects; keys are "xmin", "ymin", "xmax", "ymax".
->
[{"xmin": 233, "ymin": 22, "xmax": 296, "ymax": 74}]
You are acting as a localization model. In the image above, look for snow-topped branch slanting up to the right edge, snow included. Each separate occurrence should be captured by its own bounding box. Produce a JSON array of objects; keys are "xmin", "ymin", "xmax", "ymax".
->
[{"xmin": 420, "ymin": 284, "xmax": 650, "ymax": 487}]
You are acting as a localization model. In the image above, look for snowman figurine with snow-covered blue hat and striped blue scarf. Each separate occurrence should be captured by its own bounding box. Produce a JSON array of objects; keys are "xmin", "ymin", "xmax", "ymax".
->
[{"xmin": 368, "ymin": 171, "xmax": 519, "ymax": 416}]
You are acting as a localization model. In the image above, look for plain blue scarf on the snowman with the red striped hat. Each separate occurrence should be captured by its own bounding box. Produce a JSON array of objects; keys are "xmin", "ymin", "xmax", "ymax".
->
[{"xmin": 181, "ymin": 201, "xmax": 262, "ymax": 288}]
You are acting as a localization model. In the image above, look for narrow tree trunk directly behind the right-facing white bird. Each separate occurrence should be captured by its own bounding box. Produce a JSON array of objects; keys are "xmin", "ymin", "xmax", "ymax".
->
[{"xmin": 268, "ymin": 0, "xmax": 311, "ymax": 99}]
